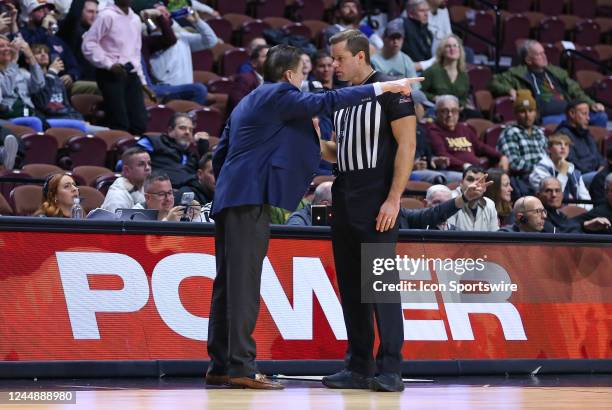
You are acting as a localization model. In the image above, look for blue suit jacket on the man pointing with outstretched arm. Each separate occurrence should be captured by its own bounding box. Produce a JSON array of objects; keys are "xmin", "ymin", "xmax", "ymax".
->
[{"xmin": 211, "ymin": 82, "xmax": 375, "ymax": 215}]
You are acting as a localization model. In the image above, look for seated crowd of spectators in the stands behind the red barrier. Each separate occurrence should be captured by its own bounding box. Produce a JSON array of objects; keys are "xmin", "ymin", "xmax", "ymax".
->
[{"xmin": 0, "ymin": 0, "xmax": 612, "ymax": 233}]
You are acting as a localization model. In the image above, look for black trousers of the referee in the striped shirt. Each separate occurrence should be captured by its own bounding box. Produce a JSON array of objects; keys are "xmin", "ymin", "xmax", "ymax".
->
[{"xmin": 332, "ymin": 170, "xmax": 404, "ymax": 377}]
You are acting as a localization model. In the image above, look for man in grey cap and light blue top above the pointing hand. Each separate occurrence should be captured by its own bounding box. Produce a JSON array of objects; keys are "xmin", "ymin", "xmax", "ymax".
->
[{"xmin": 372, "ymin": 20, "xmax": 421, "ymax": 83}]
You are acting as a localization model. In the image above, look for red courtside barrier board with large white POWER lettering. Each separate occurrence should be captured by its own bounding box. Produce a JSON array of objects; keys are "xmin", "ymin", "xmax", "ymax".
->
[{"xmin": 0, "ymin": 217, "xmax": 612, "ymax": 378}]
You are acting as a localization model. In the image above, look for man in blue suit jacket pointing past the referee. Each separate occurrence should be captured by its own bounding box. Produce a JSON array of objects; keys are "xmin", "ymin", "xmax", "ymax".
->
[{"xmin": 206, "ymin": 45, "xmax": 416, "ymax": 389}]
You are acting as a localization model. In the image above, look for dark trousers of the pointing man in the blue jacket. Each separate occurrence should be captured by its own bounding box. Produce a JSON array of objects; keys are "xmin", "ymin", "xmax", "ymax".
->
[{"xmin": 208, "ymin": 205, "xmax": 270, "ymax": 377}]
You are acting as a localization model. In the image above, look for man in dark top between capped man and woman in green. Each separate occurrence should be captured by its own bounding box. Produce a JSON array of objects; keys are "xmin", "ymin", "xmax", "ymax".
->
[{"xmin": 389, "ymin": 0, "xmax": 435, "ymax": 71}]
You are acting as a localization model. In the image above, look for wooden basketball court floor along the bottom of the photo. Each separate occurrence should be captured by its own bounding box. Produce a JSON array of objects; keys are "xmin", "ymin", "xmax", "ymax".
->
[{"xmin": 0, "ymin": 376, "xmax": 612, "ymax": 410}]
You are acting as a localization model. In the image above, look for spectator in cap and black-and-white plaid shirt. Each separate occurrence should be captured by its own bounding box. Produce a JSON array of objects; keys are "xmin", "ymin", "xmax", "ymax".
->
[{"xmin": 497, "ymin": 90, "xmax": 547, "ymax": 196}]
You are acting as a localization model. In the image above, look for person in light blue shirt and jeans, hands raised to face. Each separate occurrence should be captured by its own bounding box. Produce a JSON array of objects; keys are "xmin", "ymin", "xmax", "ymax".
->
[{"xmin": 150, "ymin": 4, "xmax": 219, "ymax": 105}]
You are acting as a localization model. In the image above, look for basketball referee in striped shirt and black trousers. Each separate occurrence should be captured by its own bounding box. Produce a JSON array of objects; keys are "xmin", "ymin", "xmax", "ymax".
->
[{"xmin": 321, "ymin": 30, "xmax": 416, "ymax": 391}]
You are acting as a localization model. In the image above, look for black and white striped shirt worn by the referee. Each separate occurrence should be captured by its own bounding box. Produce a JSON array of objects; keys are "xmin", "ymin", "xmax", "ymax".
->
[{"xmin": 332, "ymin": 72, "xmax": 415, "ymax": 172}]
